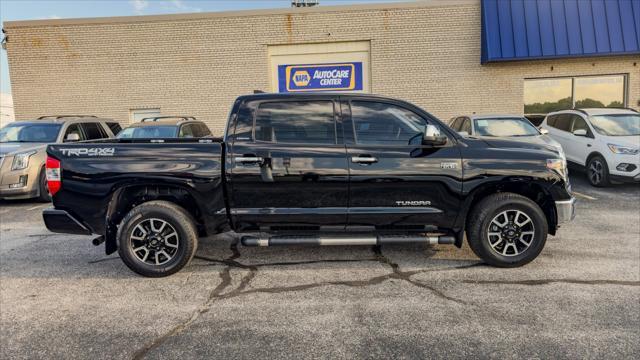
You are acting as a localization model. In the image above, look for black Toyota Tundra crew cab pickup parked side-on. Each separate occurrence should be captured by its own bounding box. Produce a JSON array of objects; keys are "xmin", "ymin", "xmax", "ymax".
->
[{"xmin": 43, "ymin": 93, "xmax": 575, "ymax": 276}]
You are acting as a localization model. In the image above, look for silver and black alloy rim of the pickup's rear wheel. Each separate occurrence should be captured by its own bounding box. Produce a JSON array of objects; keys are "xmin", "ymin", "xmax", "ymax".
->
[{"xmin": 129, "ymin": 218, "xmax": 180, "ymax": 265}]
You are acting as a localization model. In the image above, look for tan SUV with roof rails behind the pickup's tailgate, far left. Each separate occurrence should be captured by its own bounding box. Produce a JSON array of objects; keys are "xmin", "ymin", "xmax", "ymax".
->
[{"xmin": 0, "ymin": 115, "xmax": 120, "ymax": 201}]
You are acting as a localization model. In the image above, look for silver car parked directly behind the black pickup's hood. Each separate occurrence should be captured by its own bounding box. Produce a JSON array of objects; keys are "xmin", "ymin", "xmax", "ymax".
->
[{"xmin": 449, "ymin": 115, "xmax": 564, "ymax": 156}]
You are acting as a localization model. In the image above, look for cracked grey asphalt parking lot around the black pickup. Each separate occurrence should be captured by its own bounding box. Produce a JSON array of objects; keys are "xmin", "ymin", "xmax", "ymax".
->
[{"xmin": 0, "ymin": 176, "xmax": 640, "ymax": 359}]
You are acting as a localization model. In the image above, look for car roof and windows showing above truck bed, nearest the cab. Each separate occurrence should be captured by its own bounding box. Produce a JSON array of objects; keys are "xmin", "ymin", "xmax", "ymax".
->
[{"xmin": 118, "ymin": 116, "xmax": 211, "ymax": 139}]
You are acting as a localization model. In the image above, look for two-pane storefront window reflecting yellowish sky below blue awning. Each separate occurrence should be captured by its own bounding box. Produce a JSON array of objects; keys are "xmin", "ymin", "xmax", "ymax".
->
[{"xmin": 524, "ymin": 75, "xmax": 626, "ymax": 114}]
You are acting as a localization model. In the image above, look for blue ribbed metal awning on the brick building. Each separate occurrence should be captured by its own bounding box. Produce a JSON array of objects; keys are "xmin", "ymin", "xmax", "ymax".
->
[{"xmin": 481, "ymin": 0, "xmax": 640, "ymax": 64}]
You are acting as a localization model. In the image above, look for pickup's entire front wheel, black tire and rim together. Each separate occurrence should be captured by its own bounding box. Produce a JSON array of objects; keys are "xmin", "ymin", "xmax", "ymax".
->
[{"xmin": 467, "ymin": 193, "xmax": 549, "ymax": 267}]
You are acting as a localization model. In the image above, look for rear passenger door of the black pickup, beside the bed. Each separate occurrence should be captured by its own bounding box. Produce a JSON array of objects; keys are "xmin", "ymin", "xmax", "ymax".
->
[{"xmin": 222, "ymin": 96, "xmax": 349, "ymax": 231}]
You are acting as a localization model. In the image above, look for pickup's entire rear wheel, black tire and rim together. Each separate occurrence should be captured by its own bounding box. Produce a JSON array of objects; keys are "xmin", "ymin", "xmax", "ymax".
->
[{"xmin": 117, "ymin": 201, "xmax": 198, "ymax": 277}]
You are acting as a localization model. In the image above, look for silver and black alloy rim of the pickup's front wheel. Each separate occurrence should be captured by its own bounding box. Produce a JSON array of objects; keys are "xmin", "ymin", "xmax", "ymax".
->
[{"xmin": 487, "ymin": 210, "xmax": 535, "ymax": 256}]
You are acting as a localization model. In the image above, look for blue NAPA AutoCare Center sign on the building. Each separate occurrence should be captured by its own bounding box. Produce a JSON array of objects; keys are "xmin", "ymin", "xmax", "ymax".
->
[{"xmin": 278, "ymin": 62, "xmax": 362, "ymax": 92}]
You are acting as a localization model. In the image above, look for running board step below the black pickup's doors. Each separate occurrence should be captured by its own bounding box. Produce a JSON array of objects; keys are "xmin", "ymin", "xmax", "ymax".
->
[{"xmin": 240, "ymin": 235, "xmax": 456, "ymax": 246}]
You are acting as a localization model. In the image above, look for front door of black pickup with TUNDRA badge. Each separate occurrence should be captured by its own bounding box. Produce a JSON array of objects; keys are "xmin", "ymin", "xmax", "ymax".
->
[{"xmin": 341, "ymin": 98, "xmax": 462, "ymax": 230}]
